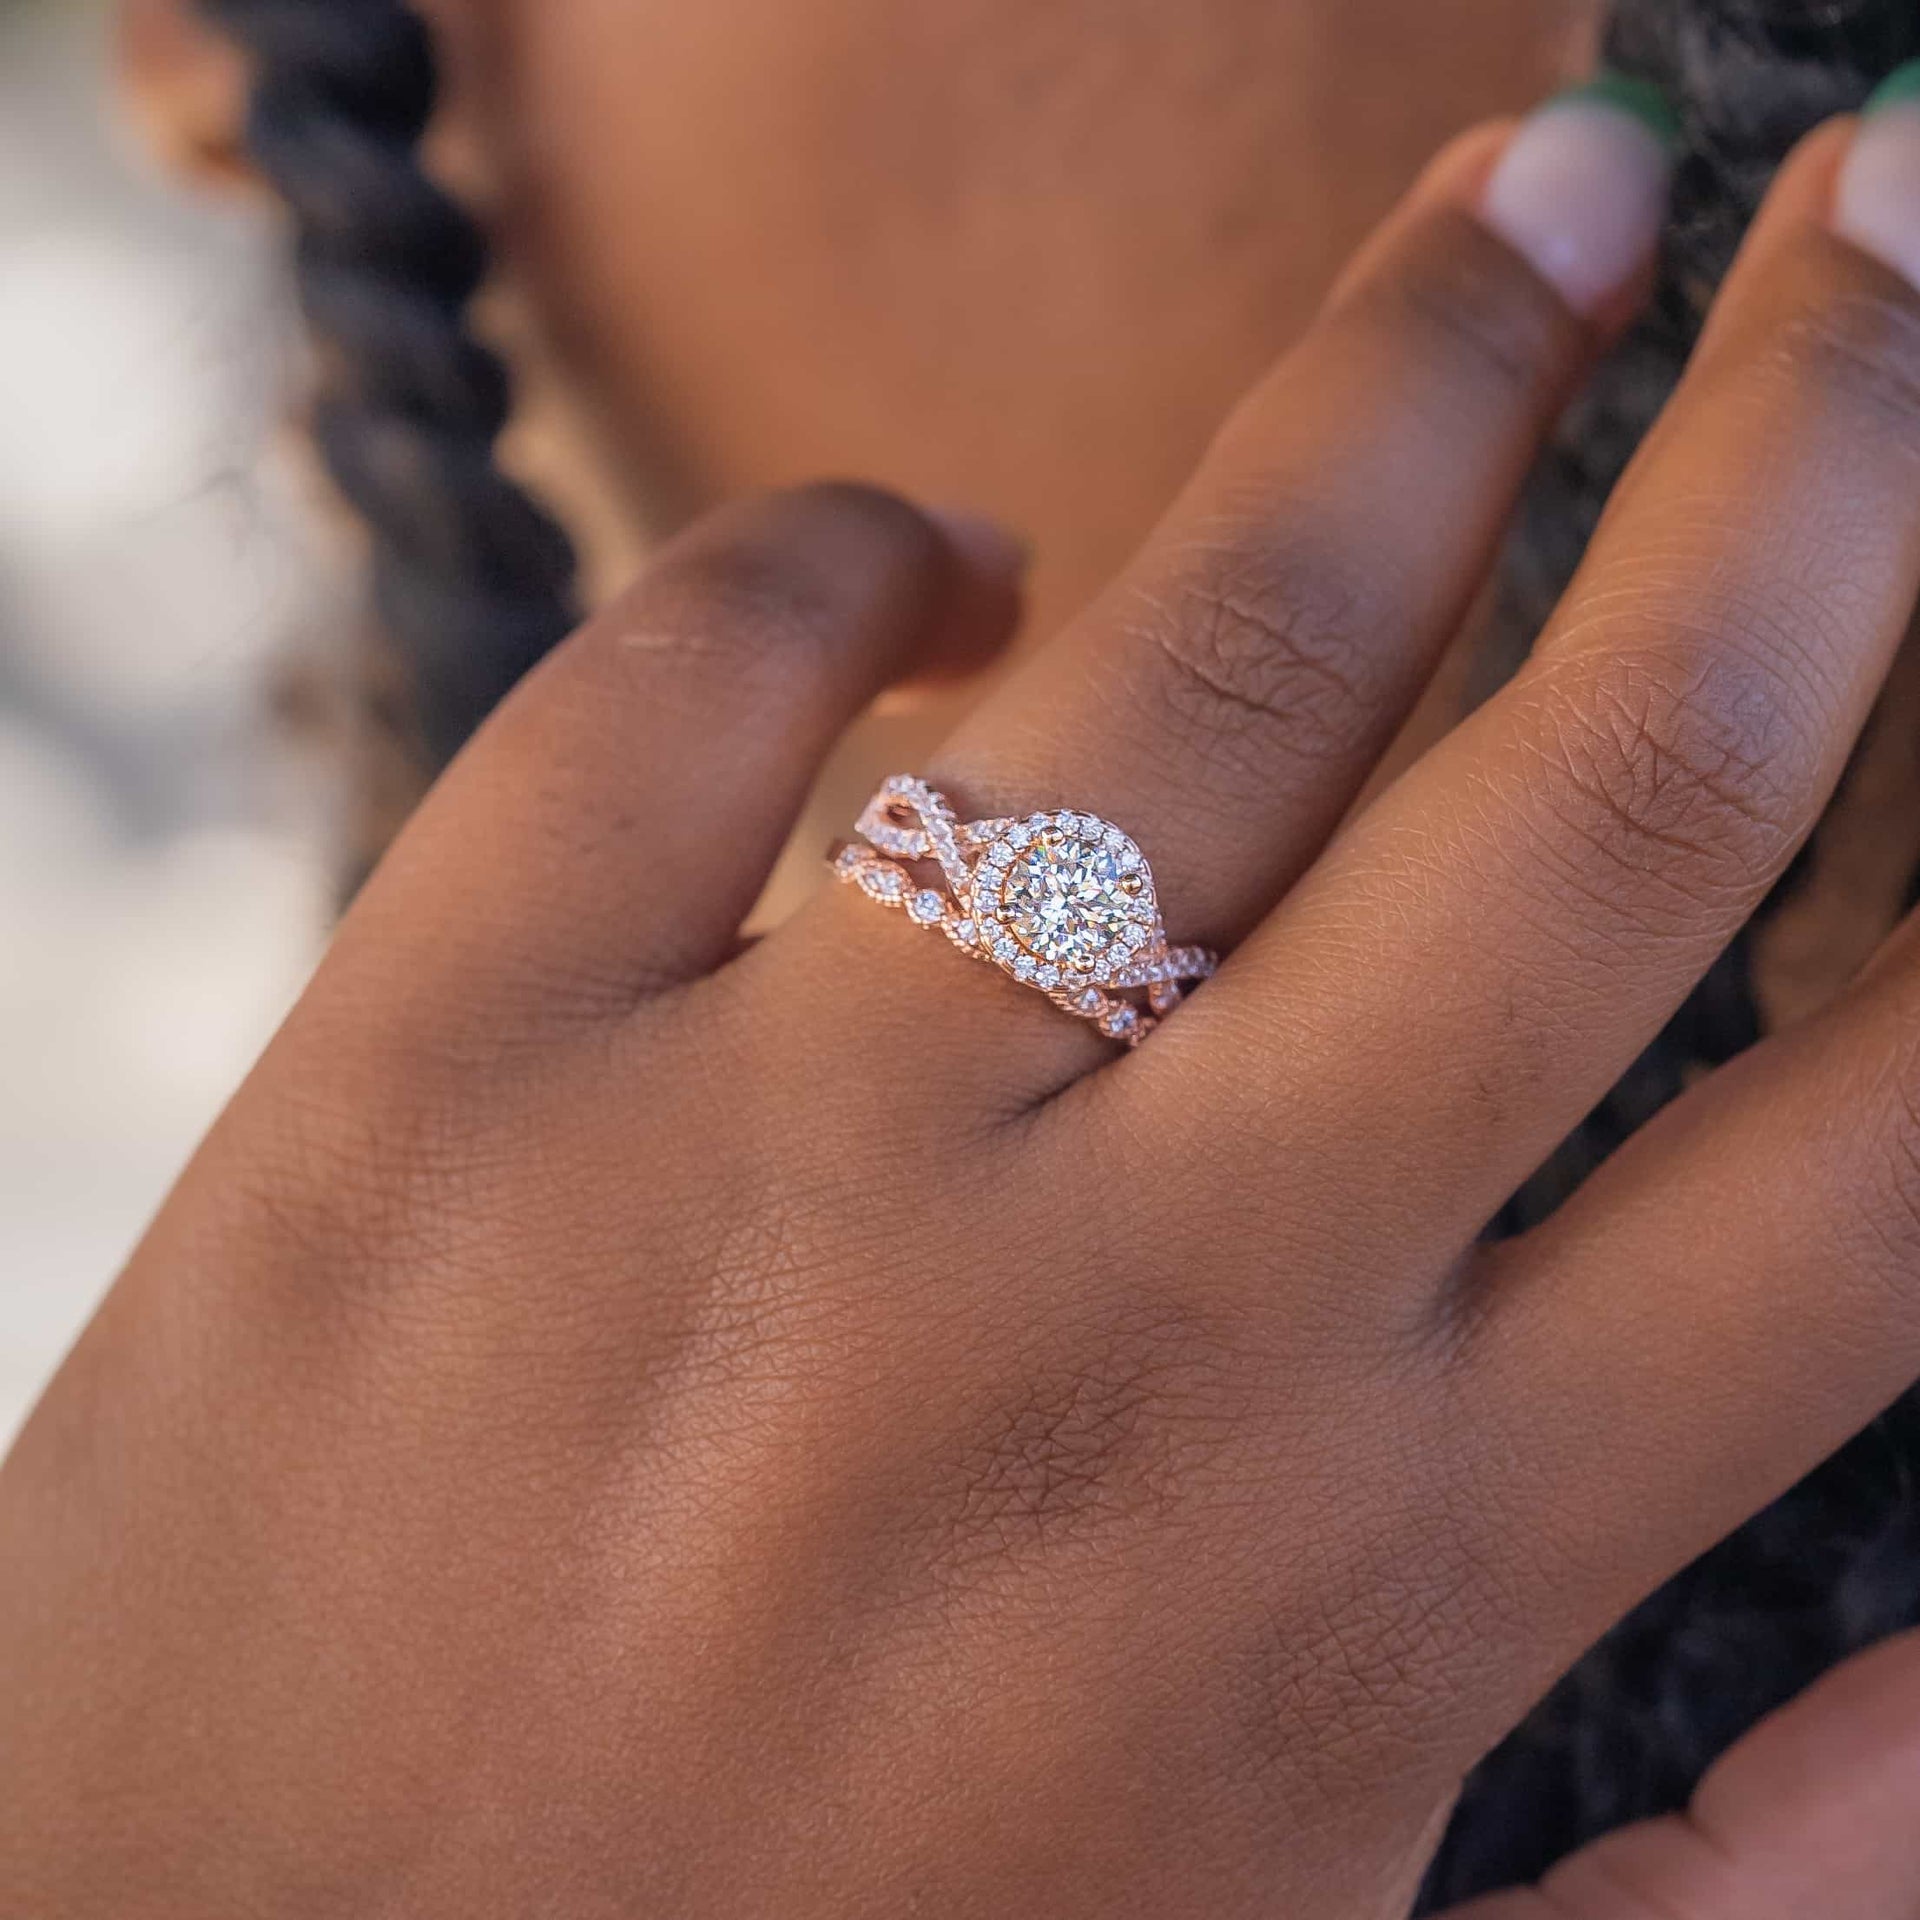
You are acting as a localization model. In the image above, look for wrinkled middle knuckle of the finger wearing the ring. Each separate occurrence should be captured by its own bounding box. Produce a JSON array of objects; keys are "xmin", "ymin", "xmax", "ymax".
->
[{"xmin": 1135, "ymin": 507, "xmax": 1384, "ymax": 772}]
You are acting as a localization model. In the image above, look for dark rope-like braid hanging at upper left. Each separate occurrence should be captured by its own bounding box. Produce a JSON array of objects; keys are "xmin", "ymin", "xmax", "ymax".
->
[{"xmin": 200, "ymin": 0, "xmax": 576, "ymax": 772}]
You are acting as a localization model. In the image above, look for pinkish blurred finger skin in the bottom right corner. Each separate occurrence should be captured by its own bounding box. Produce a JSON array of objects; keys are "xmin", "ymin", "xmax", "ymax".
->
[{"xmin": 1448, "ymin": 1634, "xmax": 1920, "ymax": 1920}]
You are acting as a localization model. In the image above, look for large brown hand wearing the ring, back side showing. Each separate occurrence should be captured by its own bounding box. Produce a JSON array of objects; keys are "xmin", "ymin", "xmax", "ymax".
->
[{"xmin": 0, "ymin": 105, "xmax": 1920, "ymax": 1920}]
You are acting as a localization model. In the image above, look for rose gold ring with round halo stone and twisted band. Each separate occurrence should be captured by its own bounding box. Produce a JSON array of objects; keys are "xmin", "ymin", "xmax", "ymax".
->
[{"xmin": 833, "ymin": 774, "xmax": 1215, "ymax": 1046}]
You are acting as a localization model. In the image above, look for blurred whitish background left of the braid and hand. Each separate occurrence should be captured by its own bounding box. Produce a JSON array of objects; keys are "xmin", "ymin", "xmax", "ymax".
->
[{"xmin": 0, "ymin": 0, "xmax": 339, "ymax": 1448}]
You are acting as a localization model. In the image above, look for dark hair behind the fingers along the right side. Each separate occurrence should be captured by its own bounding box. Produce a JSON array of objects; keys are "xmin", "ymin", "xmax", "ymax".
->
[{"xmin": 1421, "ymin": 0, "xmax": 1920, "ymax": 1912}]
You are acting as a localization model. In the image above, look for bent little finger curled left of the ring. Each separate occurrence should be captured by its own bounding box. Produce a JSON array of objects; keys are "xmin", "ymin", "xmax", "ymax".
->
[{"xmin": 340, "ymin": 486, "xmax": 1023, "ymax": 1018}]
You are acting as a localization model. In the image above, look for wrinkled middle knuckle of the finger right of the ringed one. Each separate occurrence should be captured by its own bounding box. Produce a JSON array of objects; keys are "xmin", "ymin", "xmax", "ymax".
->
[{"xmin": 1528, "ymin": 645, "xmax": 1818, "ymax": 902}]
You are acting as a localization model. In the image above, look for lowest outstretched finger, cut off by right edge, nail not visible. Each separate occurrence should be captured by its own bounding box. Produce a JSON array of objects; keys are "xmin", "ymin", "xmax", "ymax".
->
[{"xmin": 1459, "ymin": 883, "xmax": 1920, "ymax": 1645}]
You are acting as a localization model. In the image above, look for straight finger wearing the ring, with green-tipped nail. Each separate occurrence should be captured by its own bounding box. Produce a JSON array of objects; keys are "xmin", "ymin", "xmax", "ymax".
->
[{"xmin": 794, "ymin": 102, "xmax": 1667, "ymax": 1058}]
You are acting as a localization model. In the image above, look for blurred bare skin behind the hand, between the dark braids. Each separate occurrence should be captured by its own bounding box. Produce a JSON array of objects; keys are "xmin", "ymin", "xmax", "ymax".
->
[{"xmin": 445, "ymin": 0, "xmax": 1586, "ymax": 630}]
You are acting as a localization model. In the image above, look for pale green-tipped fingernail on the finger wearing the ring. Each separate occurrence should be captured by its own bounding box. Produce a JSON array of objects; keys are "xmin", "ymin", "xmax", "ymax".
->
[{"xmin": 1480, "ymin": 73, "xmax": 1680, "ymax": 313}]
